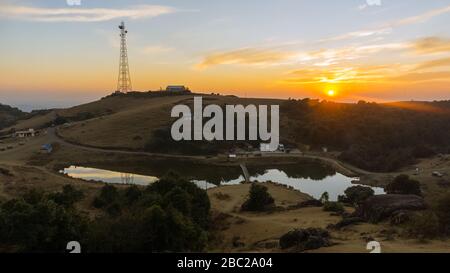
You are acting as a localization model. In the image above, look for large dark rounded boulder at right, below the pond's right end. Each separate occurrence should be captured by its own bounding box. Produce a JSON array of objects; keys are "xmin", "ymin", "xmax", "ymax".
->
[{"xmin": 354, "ymin": 194, "xmax": 426, "ymax": 222}]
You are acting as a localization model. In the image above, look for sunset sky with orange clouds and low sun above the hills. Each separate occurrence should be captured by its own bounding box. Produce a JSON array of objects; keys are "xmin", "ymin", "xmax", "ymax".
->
[{"xmin": 0, "ymin": 0, "xmax": 450, "ymax": 109}]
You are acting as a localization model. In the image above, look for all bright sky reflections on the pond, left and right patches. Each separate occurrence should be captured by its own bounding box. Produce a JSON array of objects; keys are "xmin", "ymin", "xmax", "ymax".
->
[{"xmin": 62, "ymin": 166, "xmax": 385, "ymax": 201}]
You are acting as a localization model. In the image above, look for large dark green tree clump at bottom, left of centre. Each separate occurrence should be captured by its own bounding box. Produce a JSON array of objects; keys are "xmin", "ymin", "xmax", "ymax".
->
[{"xmin": 87, "ymin": 173, "xmax": 210, "ymax": 252}]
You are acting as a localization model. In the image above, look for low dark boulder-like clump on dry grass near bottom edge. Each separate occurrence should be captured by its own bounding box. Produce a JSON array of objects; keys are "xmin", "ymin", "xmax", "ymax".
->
[{"xmin": 280, "ymin": 228, "xmax": 331, "ymax": 251}]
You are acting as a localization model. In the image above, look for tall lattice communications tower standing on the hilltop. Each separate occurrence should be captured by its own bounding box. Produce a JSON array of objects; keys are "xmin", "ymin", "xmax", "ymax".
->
[{"xmin": 117, "ymin": 22, "xmax": 132, "ymax": 93}]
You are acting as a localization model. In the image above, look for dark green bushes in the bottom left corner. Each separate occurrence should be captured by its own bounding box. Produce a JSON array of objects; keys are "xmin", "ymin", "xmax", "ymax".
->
[{"xmin": 0, "ymin": 192, "xmax": 87, "ymax": 252}]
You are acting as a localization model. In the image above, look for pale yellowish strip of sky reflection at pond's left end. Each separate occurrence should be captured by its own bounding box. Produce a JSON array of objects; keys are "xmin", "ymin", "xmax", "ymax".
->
[{"xmin": 62, "ymin": 166, "xmax": 158, "ymax": 186}]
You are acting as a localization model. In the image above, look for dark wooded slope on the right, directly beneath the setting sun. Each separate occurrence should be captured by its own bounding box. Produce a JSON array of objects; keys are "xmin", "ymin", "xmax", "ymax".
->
[{"xmin": 281, "ymin": 99, "xmax": 450, "ymax": 171}]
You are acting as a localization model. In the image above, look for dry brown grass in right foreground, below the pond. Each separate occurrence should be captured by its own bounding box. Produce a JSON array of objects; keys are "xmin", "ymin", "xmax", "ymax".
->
[{"xmin": 208, "ymin": 184, "xmax": 450, "ymax": 253}]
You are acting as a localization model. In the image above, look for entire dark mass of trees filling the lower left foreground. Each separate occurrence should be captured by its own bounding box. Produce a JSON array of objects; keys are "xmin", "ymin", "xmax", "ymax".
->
[{"xmin": 0, "ymin": 174, "xmax": 210, "ymax": 252}]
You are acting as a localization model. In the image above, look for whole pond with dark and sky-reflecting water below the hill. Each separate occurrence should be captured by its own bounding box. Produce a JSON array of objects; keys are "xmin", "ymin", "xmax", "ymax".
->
[{"xmin": 61, "ymin": 161, "xmax": 385, "ymax": 201}]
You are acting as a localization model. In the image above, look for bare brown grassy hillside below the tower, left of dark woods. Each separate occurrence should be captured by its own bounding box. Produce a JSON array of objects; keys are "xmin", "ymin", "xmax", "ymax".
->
[{"xmin": 6, "ymin": 93, "xmax": 281, "ymax": 150}]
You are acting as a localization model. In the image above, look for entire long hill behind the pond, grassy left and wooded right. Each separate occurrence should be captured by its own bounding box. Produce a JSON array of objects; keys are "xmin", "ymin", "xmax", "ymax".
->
[{"xmin": 6, "ymin": 93, "xmax": 450, "ymax": 171}]
